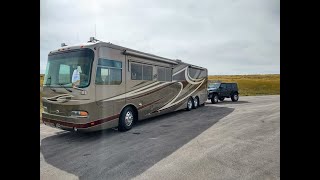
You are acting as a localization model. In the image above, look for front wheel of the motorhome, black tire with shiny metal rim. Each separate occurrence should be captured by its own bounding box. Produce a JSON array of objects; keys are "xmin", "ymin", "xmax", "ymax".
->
[{"xmin": 118, "ymin": 106, "xmax": 137, "ymax": 132}]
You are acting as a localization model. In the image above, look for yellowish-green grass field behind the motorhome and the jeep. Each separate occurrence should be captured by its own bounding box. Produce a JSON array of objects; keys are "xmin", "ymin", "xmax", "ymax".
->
[{"xmin": 40, "ymin": 74, "xmax": 280, "ymax": 120}]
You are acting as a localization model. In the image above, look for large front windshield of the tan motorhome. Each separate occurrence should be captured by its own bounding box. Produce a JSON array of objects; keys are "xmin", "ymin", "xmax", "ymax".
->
[{"xmin": 44, "ymin": 49, "xmax": 94, "ymax": 88}]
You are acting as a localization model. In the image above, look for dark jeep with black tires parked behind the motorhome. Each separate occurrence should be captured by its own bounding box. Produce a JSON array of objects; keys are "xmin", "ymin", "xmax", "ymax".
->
[{"xmin": 208, "ymin": 83, "xmax": 239, "ymax": 104}]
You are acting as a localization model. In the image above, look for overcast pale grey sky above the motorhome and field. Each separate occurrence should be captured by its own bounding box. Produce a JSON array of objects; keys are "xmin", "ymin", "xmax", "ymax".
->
[{"xmin": 40, "ymin": 0, "xmax": 280, "ymax": 75}]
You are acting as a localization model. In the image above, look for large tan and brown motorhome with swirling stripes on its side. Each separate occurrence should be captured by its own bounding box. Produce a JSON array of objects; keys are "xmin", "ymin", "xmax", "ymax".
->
[{"xmin": 42, "ymin": 38, "xmax": 208, "ymax": 131}]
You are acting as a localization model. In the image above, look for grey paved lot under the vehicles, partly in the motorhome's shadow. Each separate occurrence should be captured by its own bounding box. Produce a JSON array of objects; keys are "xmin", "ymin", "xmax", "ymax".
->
[{"xmin": 40, "ymin": 96, "xmax": 280, "ymax": 179}]
